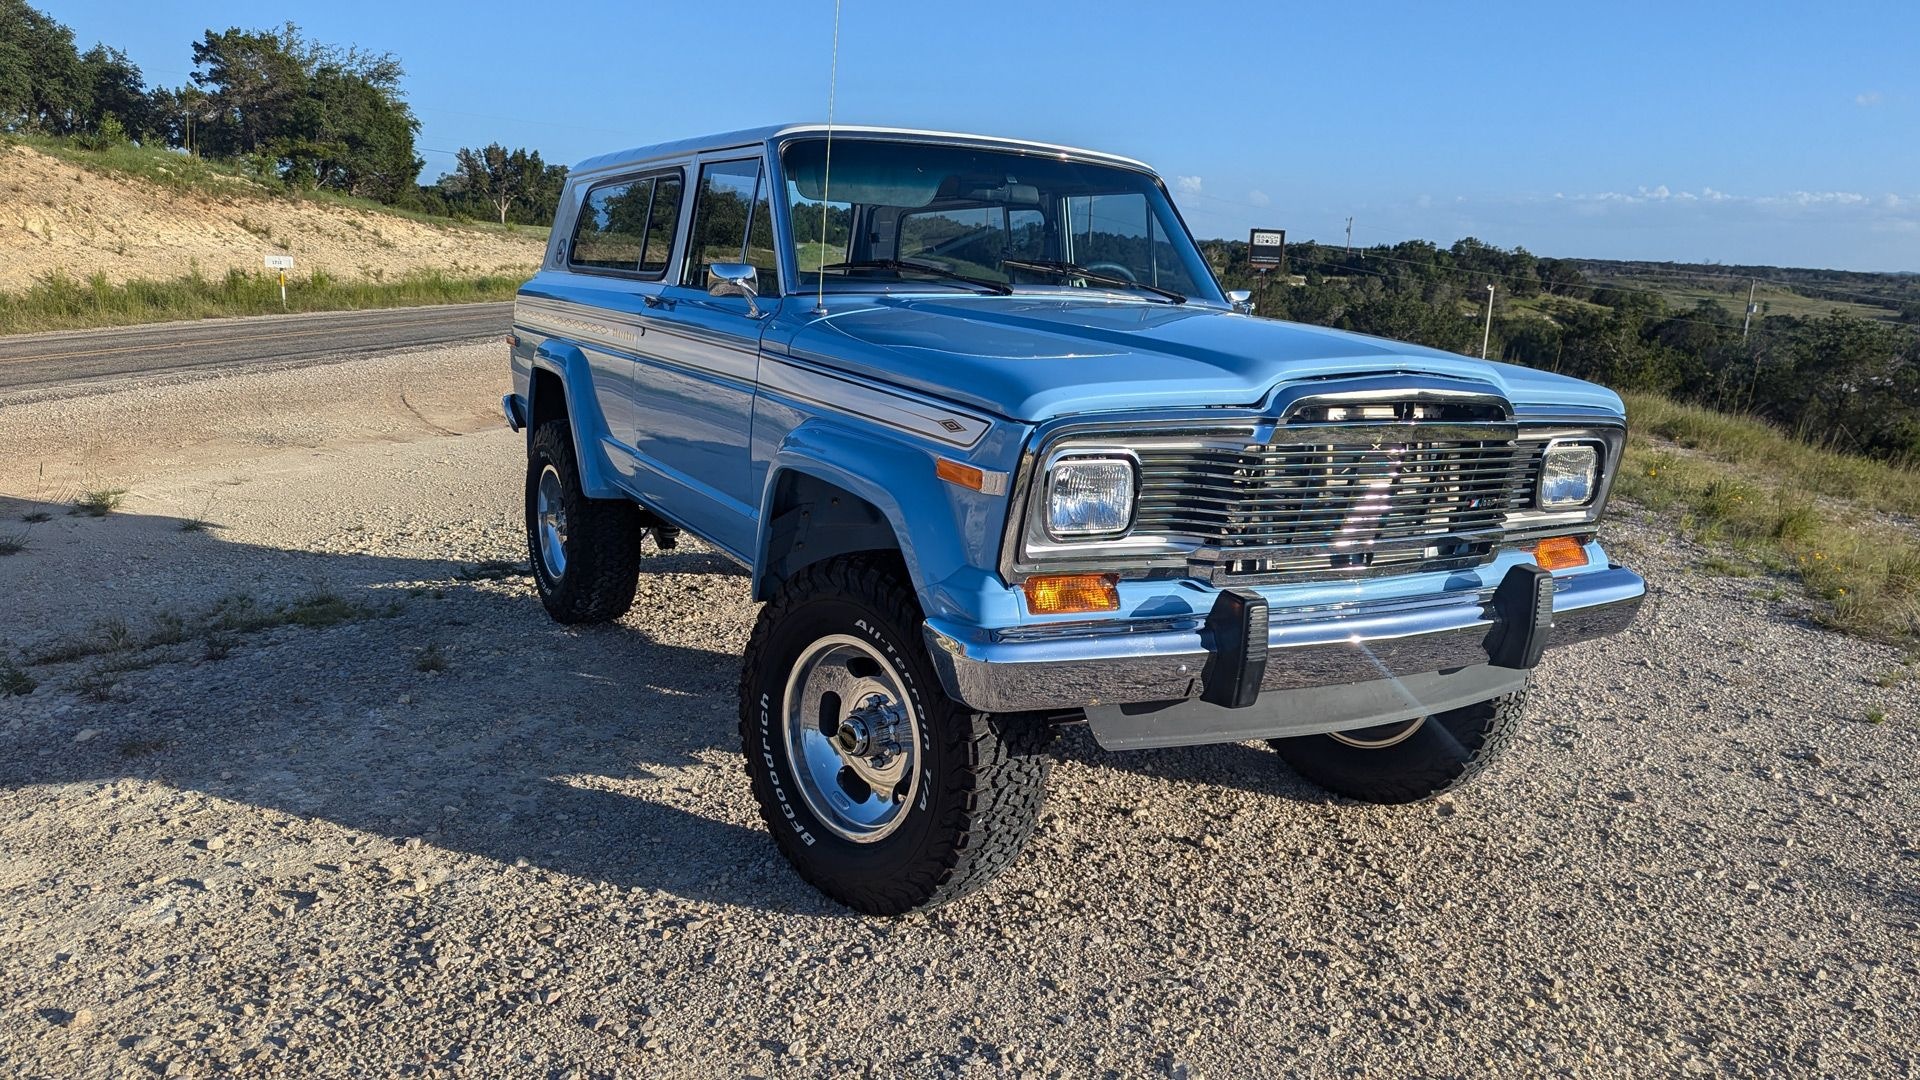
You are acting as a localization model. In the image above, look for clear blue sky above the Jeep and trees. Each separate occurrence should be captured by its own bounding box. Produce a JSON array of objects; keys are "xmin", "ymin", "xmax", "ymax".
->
[{"xmin": 40, "ymin": 0, "xmax": 1920, "ymax": 271}]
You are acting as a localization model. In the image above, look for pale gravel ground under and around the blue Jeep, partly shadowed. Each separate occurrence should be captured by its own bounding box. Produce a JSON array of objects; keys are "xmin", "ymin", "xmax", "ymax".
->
[{"xmin": 0, "ymin": 346, "xmax": 1920, "ymax": 1078}]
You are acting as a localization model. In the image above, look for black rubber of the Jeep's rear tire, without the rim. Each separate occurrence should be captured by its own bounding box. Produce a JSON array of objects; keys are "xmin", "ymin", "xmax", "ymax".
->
[{"xmin": 526, "ymin": 419, "xmax": 645, "ymax": 623}]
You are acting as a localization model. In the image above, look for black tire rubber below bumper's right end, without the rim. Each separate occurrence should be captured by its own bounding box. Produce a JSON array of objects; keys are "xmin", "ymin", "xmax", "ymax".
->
[{"xmin": 1267, "ymin": 688, "xmax": 1526, "ymax": 803}]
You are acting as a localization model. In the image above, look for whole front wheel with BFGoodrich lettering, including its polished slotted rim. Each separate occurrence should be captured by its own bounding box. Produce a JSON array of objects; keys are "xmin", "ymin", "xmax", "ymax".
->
[{"xmin": 739, "ymin": 557, "xmax": 1052, "ymax": 915}]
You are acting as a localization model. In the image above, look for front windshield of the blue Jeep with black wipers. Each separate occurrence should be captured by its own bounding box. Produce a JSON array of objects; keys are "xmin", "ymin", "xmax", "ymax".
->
[{"xmin": 780, "ymin": 138, "xmax": 1221, "ymax": 304}]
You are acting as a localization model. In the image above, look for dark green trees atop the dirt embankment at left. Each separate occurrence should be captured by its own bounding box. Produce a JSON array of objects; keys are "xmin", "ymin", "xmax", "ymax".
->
[{"xmin": 0, "ymin": 0, "xmax": 566, "ymax": 225}]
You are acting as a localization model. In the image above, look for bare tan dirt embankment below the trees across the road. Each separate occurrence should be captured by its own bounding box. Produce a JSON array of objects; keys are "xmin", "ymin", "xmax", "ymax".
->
[{"xmin": 0, "ymin": 146, "xmax": 545, "ymax": 290}]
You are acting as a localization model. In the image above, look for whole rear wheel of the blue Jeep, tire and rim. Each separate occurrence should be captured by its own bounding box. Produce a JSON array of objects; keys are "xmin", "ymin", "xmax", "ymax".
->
[{"xmin": 526, "ymin": 421, "xmax": 645, "ymax": 623}]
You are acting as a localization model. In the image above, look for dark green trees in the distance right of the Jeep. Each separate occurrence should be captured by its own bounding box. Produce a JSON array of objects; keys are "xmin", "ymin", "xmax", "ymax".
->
[{"xmin": 1206, "ymin": 238, "xmax": 1920, "ymax": 463}]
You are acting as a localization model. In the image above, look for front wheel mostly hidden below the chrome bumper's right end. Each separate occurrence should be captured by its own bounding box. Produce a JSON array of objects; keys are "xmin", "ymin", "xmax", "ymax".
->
[{"xmin": 1269, "ymin": 688, "xmax": 1526, "ymax": 803}]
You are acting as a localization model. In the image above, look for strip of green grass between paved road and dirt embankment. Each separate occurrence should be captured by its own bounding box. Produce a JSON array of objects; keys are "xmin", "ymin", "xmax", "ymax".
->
[{"xmin": 0, "ymin": 269, "xmax": 524, "ymax": 334}]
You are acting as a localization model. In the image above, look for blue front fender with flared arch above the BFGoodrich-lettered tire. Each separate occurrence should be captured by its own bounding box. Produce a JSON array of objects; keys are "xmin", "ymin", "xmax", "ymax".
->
[{"xmin": 753, "ymin": 417, "xmax": 1006, "ymax": 619}]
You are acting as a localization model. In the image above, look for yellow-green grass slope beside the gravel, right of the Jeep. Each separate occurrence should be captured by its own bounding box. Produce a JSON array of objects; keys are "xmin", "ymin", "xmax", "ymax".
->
[{"xmin": 1615, "ymin": 396, "xmax": 1920, "ymax": 642}]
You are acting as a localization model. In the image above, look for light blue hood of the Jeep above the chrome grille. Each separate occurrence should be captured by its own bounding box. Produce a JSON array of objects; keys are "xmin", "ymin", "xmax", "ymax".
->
[{"xmin": 768, "ymin": 296, "xmax": 1620, "ymax": 423}]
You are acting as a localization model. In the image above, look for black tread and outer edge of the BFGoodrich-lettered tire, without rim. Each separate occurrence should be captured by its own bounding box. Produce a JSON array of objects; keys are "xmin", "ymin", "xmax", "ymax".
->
[{"xmin": 739, "ymin": 555, "xmax": 1054, "ymax": 915}]
